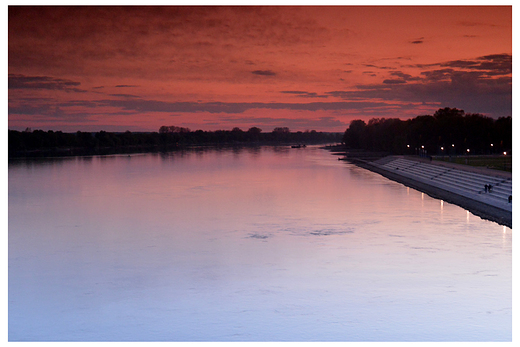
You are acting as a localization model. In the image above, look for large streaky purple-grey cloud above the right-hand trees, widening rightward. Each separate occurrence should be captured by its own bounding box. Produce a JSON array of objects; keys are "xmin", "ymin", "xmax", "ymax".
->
[{"xmin": 325, "ymin": 58, "xmax": 512, "ymax": 118}]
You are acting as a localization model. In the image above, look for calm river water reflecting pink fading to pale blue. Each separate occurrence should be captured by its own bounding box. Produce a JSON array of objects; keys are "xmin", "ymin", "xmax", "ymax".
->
[{"xmin": 8, "ymin": 147, "xmax": 512, "ymax": 341}]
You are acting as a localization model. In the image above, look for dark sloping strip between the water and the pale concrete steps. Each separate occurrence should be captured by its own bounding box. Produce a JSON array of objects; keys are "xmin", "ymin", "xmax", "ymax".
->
[{"xmin": 334, "ymin": 149, "xmax": 513, "ymax": 228}]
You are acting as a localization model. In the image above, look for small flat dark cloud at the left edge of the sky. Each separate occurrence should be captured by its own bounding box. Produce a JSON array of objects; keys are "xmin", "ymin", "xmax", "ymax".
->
[{"xmin": 7, "ymin": 74, "xmax": 86, "ymax": 93}]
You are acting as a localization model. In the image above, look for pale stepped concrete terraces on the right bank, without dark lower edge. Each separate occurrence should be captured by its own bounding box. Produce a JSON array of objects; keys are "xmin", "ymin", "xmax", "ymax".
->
[{"xmin": 370, "ymin": 156, "xmax": 512, "ymax": 213}]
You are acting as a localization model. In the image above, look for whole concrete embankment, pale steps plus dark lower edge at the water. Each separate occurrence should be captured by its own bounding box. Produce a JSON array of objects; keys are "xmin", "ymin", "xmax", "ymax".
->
[{"xmin": 345, "ymin": 154, "xmax": 513, "ymax": 228}]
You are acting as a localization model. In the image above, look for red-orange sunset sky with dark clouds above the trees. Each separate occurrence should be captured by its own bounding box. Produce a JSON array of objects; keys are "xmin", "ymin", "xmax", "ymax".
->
[{"xmin": 8, "ymin": 6, "xmax": 512, "ymax": 132}]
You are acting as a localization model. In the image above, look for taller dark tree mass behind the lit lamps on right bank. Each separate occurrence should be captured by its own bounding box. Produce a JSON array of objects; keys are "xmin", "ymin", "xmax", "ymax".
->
[{"xmin": 343, "ymin": 107, "xmax": 513, "ymax": 155}]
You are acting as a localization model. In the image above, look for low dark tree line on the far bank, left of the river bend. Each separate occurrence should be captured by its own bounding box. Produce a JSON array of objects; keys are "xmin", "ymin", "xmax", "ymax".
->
[{"xmin": 8, "ymin": 126, "xmax": 342, "ymax": 157}]
